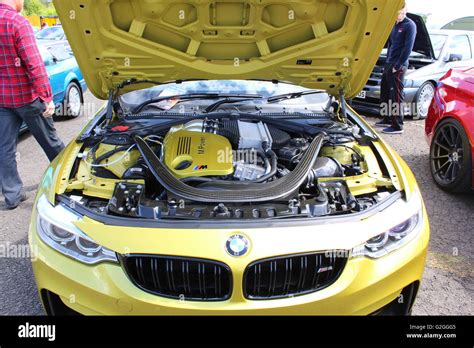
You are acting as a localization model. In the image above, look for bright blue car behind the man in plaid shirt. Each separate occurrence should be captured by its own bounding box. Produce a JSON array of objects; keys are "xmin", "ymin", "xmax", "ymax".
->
[{"xmin": 21, "ymin": 44, "xmax": 87, "ymax": 132}]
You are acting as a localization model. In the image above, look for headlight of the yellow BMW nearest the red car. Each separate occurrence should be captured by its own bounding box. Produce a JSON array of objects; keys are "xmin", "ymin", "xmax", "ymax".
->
[{"xmin": 351, "ymin": 192, "xmax": 423, "ymax": 259}]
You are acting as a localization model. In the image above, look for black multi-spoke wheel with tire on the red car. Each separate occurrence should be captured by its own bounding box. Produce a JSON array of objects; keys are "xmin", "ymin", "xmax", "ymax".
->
[{"xmin": 430, "ymin": 119, "xmax": 472, "ymax": 193}]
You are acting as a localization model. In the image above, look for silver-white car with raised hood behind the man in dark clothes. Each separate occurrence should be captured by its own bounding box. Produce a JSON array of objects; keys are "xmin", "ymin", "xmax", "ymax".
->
[{"xmin": 352, "ymin": 15, "xmax": 474, "ymax": 119}]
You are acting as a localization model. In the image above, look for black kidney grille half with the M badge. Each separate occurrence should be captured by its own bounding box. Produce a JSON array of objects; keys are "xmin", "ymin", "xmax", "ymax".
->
[{"xmin": 244, "ymin": 252, "xmax": 347, "ymax": 300}]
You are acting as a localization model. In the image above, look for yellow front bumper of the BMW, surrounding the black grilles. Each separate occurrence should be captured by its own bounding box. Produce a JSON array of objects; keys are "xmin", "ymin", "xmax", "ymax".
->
[{"xmin": 30, "ymin": 205, "xmax": 429, "ymax": 315}]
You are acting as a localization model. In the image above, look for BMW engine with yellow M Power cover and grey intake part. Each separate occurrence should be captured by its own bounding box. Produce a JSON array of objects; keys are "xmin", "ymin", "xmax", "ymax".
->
[{"xmin": 162, "ymin": 120, "xmax": 291, "ymax": 181}]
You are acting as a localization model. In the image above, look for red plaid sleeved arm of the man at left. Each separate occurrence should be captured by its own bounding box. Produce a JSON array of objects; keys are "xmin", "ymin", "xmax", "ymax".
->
[{"xmin": 15, "ymin": 23, "xmax": 53, "ymax": 104}]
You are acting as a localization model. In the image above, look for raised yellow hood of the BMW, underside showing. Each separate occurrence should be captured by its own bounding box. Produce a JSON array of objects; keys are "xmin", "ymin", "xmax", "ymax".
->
[{"xmin": 54, "ymin": 0, "xmax": 403, "ymax": 99}]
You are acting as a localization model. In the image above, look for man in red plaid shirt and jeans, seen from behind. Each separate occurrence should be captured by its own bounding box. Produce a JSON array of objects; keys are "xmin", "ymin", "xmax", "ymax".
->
[{"xmin": 0, "ymin": 0, "xmax": 64, "ymax": 209}]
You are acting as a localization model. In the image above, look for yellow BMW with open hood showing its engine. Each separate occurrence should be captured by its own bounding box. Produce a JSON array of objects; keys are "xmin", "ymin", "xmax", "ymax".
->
[{"xmin": 29, "ymin": 0, "xmax": 429, "ymax": 315}]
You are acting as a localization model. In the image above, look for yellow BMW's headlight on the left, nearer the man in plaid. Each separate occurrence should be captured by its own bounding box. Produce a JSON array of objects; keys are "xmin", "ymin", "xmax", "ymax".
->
[{"xmin": 36, "ymin": 196, "xmax": 118, "ymax": 264}]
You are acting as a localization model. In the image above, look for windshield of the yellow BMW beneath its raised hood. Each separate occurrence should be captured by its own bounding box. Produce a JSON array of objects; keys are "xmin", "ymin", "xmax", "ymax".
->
[{"xmin": 120, "ymin": 80, "xmax": 329, "ymax": 110}]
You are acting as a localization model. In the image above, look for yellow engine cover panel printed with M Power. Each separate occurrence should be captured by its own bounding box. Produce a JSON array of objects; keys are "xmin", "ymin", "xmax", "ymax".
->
[{"xmin": 163, "ymin": 129, "xmax": 234, "ymax": 178}]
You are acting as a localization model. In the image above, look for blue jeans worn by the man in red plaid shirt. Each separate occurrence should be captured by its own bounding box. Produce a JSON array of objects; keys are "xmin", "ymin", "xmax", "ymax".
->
[{"xmin": 0, "ymin": 99, "xmax": 64, "ymax": 206}]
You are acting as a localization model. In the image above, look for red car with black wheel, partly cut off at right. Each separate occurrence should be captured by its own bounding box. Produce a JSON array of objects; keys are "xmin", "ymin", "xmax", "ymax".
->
[{"xmin": 425, "ymin": 68, "xmax": 474, "ymax": 192}]
